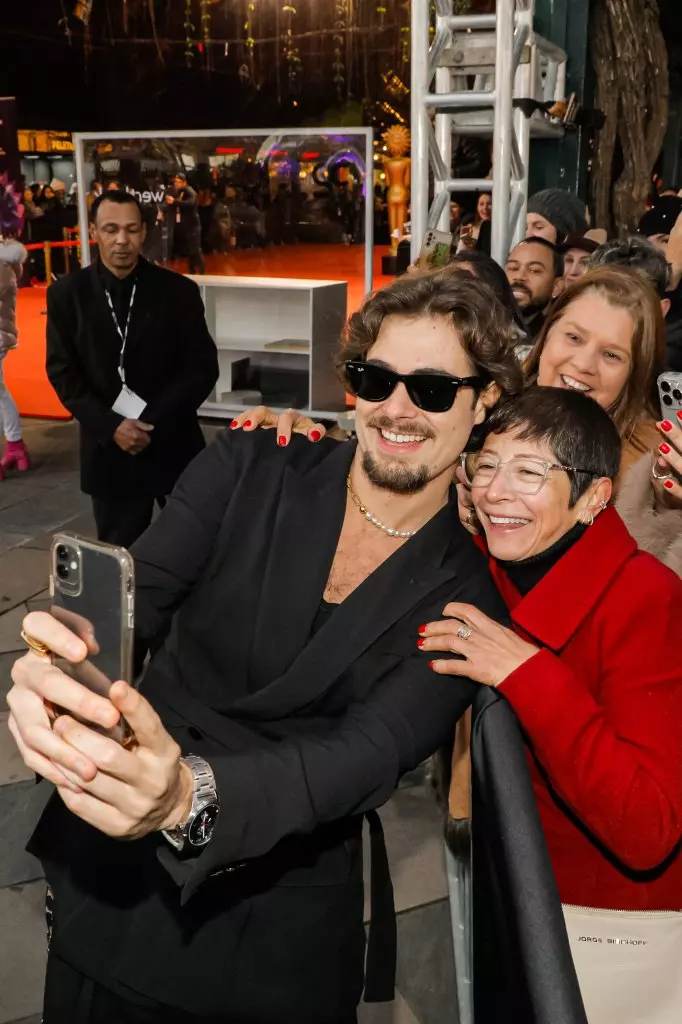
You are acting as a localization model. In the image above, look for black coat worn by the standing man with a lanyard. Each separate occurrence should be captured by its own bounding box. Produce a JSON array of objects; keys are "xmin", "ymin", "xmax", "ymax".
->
[{"xmin": 46, "ymin": 259, "xmax": 218, "ymax": 499}]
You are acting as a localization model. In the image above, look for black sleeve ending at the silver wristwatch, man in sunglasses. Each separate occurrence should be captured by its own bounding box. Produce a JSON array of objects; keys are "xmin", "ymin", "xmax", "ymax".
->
[{"xmin": 161, "ymin": 653, "xmax": 476, "ymax": 900}]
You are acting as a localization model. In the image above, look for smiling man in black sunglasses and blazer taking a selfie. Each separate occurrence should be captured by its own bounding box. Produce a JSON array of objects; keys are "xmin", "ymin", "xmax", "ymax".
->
[{"xmin": 9, "ymin": 273, "xmax": 577, "ymax": 1024}]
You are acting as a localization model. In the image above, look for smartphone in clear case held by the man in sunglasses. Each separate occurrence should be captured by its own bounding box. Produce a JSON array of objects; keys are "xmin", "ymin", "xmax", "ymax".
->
[{"xmin": 50, "ymin": 534, "xmax": 135, "ymax": 746}]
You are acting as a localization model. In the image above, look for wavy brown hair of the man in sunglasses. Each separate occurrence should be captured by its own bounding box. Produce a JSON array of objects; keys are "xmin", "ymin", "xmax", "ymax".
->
[{"xmin": 337, "ymin": 270, "xmax": 523, "ymax": 395}]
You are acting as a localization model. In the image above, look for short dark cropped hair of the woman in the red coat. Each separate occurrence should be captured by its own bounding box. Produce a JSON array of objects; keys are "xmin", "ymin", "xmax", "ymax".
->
[{"xmin": 485, "ymin": 386, "xmax": 621, "ymax": 508}]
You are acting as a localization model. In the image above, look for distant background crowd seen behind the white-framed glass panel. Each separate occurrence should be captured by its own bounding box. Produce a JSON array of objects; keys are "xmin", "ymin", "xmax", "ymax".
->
[{"xmin": 20, "ymin": 159, "xmax": 368, "ymax": 282}]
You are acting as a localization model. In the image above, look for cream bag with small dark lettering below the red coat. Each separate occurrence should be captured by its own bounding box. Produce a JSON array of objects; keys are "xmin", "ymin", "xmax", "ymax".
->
[{"xmin": 563, "ymin": 903, "xmax": 682, "ymax": 1024}]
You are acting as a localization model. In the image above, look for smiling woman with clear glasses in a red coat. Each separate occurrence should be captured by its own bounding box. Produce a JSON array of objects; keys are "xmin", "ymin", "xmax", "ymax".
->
[{"xmin": 418, "ymin": 388, "xmax": 682, "ymax": 910}]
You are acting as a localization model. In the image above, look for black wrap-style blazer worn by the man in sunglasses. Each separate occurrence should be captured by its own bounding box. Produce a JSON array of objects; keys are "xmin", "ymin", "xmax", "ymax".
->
[{"xmin": 31, "ymin": 432, "xmax": 583, "ymax": 1024}]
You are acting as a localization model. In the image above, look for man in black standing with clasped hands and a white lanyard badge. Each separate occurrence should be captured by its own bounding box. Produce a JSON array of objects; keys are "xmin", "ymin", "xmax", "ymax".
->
[{"xmin": 47, "ymin": 190, "xmax": 218, "ymax": 547}]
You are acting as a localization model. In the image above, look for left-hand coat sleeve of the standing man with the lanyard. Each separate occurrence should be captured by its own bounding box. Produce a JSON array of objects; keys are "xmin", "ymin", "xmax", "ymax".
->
[{"xmin": 45, "ymin": 287, "xmax": 123, "ymax": 444}]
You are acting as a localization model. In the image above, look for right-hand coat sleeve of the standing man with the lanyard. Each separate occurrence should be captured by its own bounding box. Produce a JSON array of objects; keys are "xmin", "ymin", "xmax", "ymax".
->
[{"xmin": 141, "ymin": 281, "xmax": 218, "ymax": 425}]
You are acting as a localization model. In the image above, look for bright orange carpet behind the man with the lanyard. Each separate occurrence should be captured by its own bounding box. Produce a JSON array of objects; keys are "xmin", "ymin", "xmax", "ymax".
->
[{"xmin": 10, "ymin": 245, "xmax": 390, "ymax": 419}]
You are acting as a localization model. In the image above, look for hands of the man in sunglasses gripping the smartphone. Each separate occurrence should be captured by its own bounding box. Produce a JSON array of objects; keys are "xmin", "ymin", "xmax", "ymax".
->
[{"xmin": 7, "ymin": 611, "xmax": 195, "ymax": 839}]
